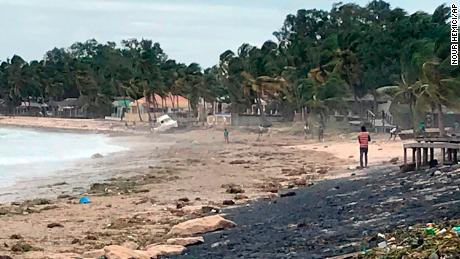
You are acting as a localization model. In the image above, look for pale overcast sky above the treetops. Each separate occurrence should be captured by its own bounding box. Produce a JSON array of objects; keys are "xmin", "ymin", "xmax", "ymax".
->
[{"xmin": 0, "ymin": 0, "xmax": 443, "ymax": 67}]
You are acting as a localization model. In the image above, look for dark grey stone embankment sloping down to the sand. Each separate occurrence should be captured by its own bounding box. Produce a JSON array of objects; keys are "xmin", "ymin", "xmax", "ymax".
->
[{"xmin": 173, "ymin": 168, "xmax": 460, "ymax": 258}]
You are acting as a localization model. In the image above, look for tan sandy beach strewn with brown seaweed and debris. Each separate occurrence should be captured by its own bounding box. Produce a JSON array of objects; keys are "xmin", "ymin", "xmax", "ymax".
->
[{"xmin": 0, "ymin": 117, "xmax": 408, "ymax": 258}]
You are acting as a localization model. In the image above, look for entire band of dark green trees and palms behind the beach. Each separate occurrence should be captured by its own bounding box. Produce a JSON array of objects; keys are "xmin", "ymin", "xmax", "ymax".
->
[{"xmin": 0, "ymin": 0, "xmax": 460, "ymax": 130}]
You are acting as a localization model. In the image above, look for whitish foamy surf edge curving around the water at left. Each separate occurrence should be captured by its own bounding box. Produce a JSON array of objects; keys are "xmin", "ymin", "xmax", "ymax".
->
[{"xmin": 0, "ymin": 124, "xmax": 151, "ymax": 204}]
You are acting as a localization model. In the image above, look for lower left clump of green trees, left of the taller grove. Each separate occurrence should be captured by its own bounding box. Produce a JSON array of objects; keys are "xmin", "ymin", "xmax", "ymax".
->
[{"xmin": 0, "ymin": 39, "xmax": 225, "ymax": 116}]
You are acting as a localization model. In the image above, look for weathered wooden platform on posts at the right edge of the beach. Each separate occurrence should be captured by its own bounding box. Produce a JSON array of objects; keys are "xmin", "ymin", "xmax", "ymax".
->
[{"xmin": 404, "ymin": 138, "xmax": 460, "ymax": 170}]
